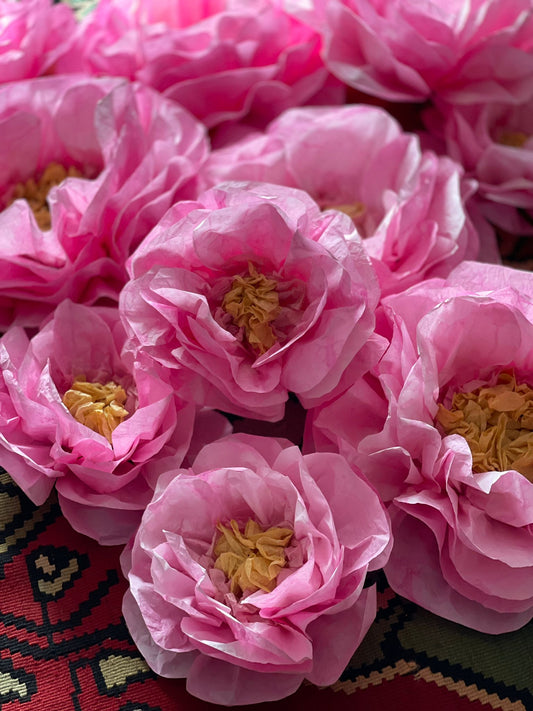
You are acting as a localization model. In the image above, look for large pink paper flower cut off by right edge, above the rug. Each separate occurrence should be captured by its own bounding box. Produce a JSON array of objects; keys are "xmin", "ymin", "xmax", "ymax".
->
[{"xmin": 307, "ymin": 262, "xmax": 533, "ymax": 633}]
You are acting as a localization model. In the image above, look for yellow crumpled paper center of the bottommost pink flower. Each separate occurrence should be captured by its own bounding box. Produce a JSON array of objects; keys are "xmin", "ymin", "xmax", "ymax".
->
[{"xmin": 214, "ymin": 519, "xmax": 293, "ymax": 594}]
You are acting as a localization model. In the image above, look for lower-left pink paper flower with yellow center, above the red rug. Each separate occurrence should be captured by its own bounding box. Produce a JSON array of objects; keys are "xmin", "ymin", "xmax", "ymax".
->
[{"xmin": 0, "ymin": 301, "xmax": 194, "ymax": 544}]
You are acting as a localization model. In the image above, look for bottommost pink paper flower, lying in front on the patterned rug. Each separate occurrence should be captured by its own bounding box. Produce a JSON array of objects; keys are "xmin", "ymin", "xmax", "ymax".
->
[{"xmin": 122, "ymin": 435, "xmax": 390, "ymax": 705}]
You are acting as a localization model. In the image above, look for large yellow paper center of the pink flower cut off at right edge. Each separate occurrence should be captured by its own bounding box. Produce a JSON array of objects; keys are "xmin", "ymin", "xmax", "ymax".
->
[{"xmin": 437, "ymin": 372, "xmax": 533, "ymax": 481}]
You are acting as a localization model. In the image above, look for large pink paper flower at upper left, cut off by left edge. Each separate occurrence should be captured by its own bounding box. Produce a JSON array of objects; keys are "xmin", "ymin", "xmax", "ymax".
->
[{"xmin": 0, "ymin": 76, "xmax": 208, "ymax": 329}]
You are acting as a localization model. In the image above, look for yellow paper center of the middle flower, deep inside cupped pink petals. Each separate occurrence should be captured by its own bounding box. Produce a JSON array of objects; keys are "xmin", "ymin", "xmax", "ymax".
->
[{"xmin": 222, "ymin": 263, "xmax": 281, "ymax": 353}]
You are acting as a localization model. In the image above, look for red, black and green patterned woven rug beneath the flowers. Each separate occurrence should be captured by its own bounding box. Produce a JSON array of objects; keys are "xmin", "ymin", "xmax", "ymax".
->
[{"xmin": 0, "ymin": 471, "xmax": 533, "ymax": 711}]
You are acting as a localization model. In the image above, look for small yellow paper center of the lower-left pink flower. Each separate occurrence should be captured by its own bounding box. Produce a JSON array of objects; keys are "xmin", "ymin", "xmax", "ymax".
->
[{"xmin": 63, "ymin": 379, "xmax": 129, "ymax": 442}]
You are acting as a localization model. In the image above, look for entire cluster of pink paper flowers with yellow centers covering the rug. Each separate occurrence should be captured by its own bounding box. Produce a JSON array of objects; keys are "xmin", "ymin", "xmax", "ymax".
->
[{"xmin": 0, "ymin": 0, "xmax": 533, "ymax": 705}]
